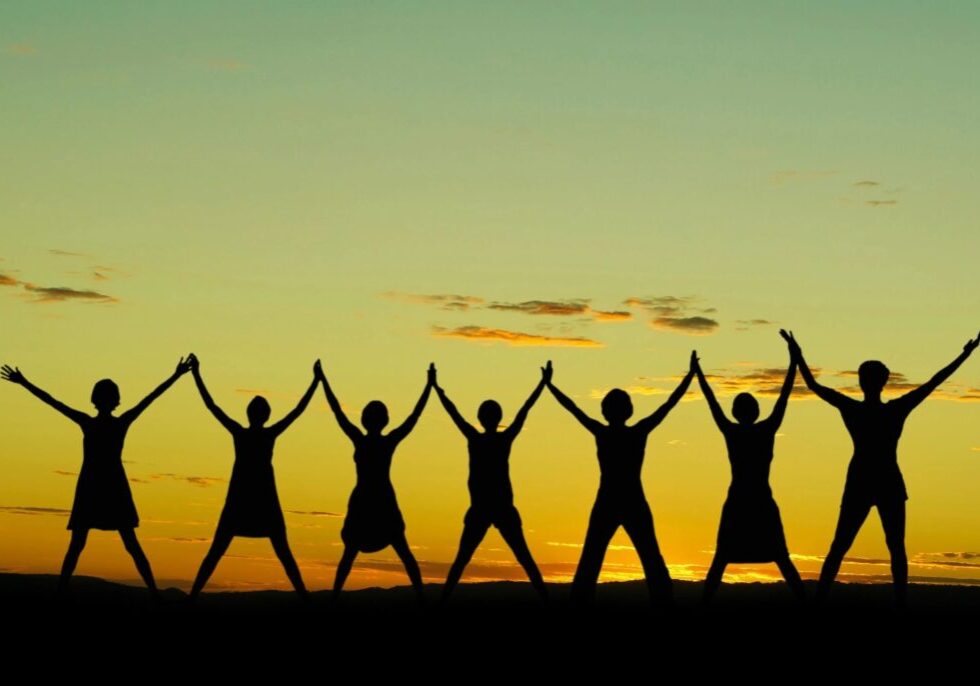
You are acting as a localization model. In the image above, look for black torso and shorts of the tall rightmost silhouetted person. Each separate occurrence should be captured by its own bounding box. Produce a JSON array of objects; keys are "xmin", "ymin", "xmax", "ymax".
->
[{"xmin": 839, "ymin": 398, "xmax": 911, "ymax": 502}]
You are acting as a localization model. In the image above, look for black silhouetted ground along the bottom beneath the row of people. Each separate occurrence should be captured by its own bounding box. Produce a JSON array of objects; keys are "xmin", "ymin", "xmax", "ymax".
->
[{"xmin": 0, "ymin": 574, "xmax": 980, "ymax": 681}]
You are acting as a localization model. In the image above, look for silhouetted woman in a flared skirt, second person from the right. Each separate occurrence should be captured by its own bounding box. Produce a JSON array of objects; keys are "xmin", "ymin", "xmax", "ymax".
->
[{"xmin": 695, "ymin": 346, "xmax": 806, "ymax": 603}]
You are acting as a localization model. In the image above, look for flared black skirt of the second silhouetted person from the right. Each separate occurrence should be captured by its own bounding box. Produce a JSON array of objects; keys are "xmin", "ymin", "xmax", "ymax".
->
[{"xmin": 716, "ymin": 492, "xmax": 789, "ymax": 562}]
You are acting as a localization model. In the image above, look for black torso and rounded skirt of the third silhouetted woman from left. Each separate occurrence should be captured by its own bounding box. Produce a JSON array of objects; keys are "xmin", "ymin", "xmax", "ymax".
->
[{"xmin": 340, "ymin": 434, "xmax": 405, "ymax": 552}]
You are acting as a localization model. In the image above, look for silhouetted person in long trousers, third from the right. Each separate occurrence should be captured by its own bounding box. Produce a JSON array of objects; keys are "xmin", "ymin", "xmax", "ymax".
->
[{"xmin": 547, "ymin": 353, "xmax": 696, "ymax": 605}]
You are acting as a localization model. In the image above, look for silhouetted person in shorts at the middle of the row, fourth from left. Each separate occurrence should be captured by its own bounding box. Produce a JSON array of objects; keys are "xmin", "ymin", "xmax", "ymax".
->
[{"xmin": 433, "ymin": 362, "xmax": 551, "ymax": 601}]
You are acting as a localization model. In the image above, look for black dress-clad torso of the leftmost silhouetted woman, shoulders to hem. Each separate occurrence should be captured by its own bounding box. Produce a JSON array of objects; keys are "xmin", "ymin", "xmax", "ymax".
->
[{"xmin": 68, "ymin": 416, "xmax": 139, "ymax": 530}]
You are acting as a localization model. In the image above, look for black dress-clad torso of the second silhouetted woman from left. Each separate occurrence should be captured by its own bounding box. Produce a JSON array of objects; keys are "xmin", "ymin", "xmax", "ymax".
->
[{"xmin": 218, "ymin": 427, "xmax": 286, "ymax": 537}]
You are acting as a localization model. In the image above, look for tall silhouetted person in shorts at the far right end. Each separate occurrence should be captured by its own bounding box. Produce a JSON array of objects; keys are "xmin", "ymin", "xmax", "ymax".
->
[{"xmin": 779, "ymin": 330, "xmax": 980, "ymax": 607}]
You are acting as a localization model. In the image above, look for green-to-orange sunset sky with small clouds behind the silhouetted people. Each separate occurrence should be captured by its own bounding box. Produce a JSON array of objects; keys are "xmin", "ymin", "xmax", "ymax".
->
[{"xmin": 0, "ymin": 1, "xmax": 980, "ymax": 589}]
